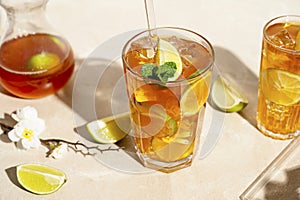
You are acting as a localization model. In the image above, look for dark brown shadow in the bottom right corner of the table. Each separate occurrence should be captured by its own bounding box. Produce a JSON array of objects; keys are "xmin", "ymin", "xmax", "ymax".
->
[{"xmin": 263, "ymin": 166, "xmax": 300, "ymax": 200}]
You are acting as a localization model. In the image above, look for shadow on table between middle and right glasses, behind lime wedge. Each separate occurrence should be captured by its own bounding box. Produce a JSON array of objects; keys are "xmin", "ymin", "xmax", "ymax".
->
[{"xmin": 214, "ymin": 46, "xmax": 258, "ymax": 127}]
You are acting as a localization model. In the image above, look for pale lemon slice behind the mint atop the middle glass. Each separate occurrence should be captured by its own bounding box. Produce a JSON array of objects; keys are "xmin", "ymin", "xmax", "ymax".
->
[{"xmin": 156, "ymin": 39, "xmax": 182, "ymax": 81}]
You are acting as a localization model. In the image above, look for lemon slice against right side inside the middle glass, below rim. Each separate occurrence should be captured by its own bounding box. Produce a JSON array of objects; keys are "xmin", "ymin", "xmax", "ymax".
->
[{"xmin": 180, "ymin": 71, "xmax": 211, "ymax": 116}]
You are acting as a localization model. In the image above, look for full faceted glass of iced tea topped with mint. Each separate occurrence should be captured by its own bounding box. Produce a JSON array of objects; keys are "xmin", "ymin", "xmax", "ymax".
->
[{"xmin": 123, "ymin": 28, "xmax": 214, "ymax": 172}]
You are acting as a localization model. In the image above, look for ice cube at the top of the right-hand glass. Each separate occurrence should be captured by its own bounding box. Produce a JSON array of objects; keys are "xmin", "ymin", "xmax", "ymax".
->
[{"xmin": 271, "ymin": 29, "xmax": 296, "ymax": 49}]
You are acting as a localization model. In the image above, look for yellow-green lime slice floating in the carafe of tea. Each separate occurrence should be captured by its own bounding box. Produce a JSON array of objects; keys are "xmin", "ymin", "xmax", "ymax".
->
[{"xmin": 26, "ymin": 52, "xmax": 60, "ymax": 71}]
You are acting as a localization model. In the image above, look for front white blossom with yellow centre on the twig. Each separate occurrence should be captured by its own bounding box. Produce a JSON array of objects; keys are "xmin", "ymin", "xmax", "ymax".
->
[{"xmin": 8, "ymin": 118, "xmax": 45, "ymax": 149}]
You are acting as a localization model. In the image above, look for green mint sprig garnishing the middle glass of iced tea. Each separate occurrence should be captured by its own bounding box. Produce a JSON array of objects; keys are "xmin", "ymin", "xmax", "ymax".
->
[{"xmin": 142, "ymin": 62, "xmax": 177, "ymax": 83}]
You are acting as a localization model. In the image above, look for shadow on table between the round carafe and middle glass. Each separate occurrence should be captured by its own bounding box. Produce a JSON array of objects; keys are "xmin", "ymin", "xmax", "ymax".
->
[{"xmin": 57, "ymin": 58, "xmax": 128, "ymax": 122}]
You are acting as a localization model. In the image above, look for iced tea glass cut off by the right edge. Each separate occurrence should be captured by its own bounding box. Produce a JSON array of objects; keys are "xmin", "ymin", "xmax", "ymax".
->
[{"xmin": 257, "ymin": 16, "xmax": 300, "ymax": 139}]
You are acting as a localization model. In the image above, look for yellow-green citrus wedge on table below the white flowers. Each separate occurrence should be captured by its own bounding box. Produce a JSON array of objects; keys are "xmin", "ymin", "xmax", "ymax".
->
[{"xmin": 17, "ymin": 164, "xmax": 67, "ymax": 194}]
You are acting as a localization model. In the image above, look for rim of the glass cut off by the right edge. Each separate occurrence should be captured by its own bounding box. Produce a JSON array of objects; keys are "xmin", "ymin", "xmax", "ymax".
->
[{"xmin": 263, "ymin": 15, "xmax": 300, "ymax": 55}]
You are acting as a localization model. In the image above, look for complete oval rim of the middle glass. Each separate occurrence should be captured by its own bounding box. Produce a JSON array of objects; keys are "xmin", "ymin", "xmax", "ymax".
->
[{"xmin": 122, "ymin": 26, "xmax": 215, "ymax": 85}]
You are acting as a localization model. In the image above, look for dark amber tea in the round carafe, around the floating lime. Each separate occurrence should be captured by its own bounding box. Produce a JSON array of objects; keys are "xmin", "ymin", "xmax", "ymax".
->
[{"xmin": 0, "ymin": 34, "xmax": 74, "ymax": 98}]
